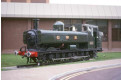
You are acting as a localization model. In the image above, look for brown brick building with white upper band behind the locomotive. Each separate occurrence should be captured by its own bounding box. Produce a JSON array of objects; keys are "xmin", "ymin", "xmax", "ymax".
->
[{"xmin": 1, "ymin": 0, "xmax": 121, "ymax": 53}]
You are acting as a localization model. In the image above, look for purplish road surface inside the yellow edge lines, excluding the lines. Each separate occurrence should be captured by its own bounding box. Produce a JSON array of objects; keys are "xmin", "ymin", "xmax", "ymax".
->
[{"xmin": 69, "ymin": 67, "xmax": 121, "ymax": 80}]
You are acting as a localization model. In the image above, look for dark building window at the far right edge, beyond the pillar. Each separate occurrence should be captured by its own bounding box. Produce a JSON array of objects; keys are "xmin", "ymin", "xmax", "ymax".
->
[{"xmin": 112, "ymin": 20, "xmax": 121, "ymax": 41}]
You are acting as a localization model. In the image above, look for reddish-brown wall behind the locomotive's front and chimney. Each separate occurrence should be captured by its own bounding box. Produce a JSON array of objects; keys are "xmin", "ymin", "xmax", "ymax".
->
[{"xmin": 1, "ymin": 18, "xmax": 55, "ymax": 53}]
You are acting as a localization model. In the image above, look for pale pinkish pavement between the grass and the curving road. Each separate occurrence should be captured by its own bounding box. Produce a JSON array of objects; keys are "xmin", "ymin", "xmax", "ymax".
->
[{"xmin": 1, "ymin": 59, "xmax": 121, "ymax": 80}]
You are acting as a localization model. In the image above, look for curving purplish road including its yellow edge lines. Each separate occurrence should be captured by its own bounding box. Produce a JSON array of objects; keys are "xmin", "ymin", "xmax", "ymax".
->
[{"xmin": 55, "ymin": 65, "xmax": 121, "ymax": 80}]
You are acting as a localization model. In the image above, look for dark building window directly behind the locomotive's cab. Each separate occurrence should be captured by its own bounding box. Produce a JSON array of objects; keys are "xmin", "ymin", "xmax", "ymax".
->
[{"xmin": 86, "ymin": 19, "xmax": 108, "ymax": 41}]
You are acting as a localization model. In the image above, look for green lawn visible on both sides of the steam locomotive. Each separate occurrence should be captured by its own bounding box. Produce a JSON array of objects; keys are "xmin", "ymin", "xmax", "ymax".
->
[{"xmin": 1, "ymin": 52, "xmax": 121, "ymax": 67}]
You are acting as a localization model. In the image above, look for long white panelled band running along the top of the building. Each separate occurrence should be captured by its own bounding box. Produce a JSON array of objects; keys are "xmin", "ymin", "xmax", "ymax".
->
[{"xmin": 1, "ymin": 2, "xmax": 121, "ymax": 19}]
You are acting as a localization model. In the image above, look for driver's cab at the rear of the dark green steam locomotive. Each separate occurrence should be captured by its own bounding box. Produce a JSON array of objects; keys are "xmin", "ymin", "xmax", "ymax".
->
[{"xmin": 82, "ymin": 24, "xmax": 103, "ymax": 50}]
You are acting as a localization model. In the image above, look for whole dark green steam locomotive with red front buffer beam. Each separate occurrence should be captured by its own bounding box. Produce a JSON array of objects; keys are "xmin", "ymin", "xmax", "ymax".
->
[{"xmin": 15, "ymin": 19, "xmax": 103, "ymax": 65}]
